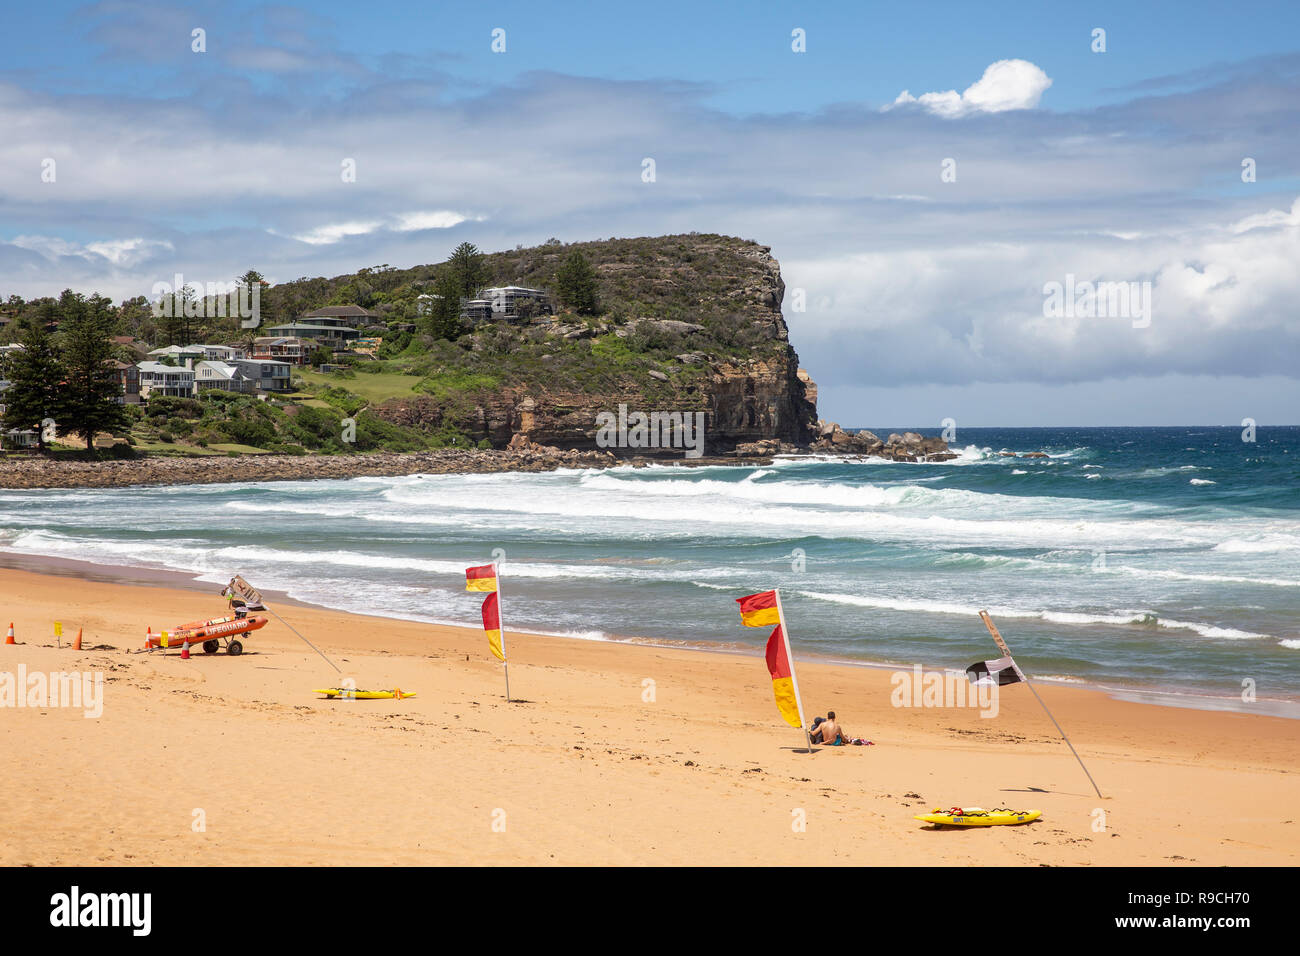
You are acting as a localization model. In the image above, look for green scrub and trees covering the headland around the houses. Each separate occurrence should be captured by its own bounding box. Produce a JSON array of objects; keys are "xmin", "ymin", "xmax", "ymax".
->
[{"xmin": 0, "ymin": 234, "xmax": 789, "ymax": 457}]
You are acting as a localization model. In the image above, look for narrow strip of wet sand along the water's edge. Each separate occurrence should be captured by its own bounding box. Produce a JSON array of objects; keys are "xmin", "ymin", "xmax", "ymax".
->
[{"xmin": 0, "ymin": 550, "xmax": 1300, "ymax": 721}]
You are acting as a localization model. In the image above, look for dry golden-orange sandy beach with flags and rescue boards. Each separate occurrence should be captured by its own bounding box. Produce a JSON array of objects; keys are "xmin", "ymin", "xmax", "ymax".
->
[{"xmin": 0, "ymin": 568, "xmax": 1300, "ymax": 866}]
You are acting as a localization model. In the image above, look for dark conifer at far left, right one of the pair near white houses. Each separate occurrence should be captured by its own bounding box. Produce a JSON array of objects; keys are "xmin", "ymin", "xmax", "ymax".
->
[{"xmin": 59, "ymin": 293, "xmax": 127, "ymax": 451}]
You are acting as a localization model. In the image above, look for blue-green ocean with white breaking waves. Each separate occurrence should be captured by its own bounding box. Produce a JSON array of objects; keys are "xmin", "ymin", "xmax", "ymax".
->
[{"xmin": 0, "ymin": 427, "xmax": 1300, "ymax": 702}]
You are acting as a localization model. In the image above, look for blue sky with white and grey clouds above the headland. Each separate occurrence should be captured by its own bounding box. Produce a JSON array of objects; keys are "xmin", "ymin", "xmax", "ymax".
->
[{"xmin": 0, "ymin": 0, "xmax": 1300, "ymax": 425}]
